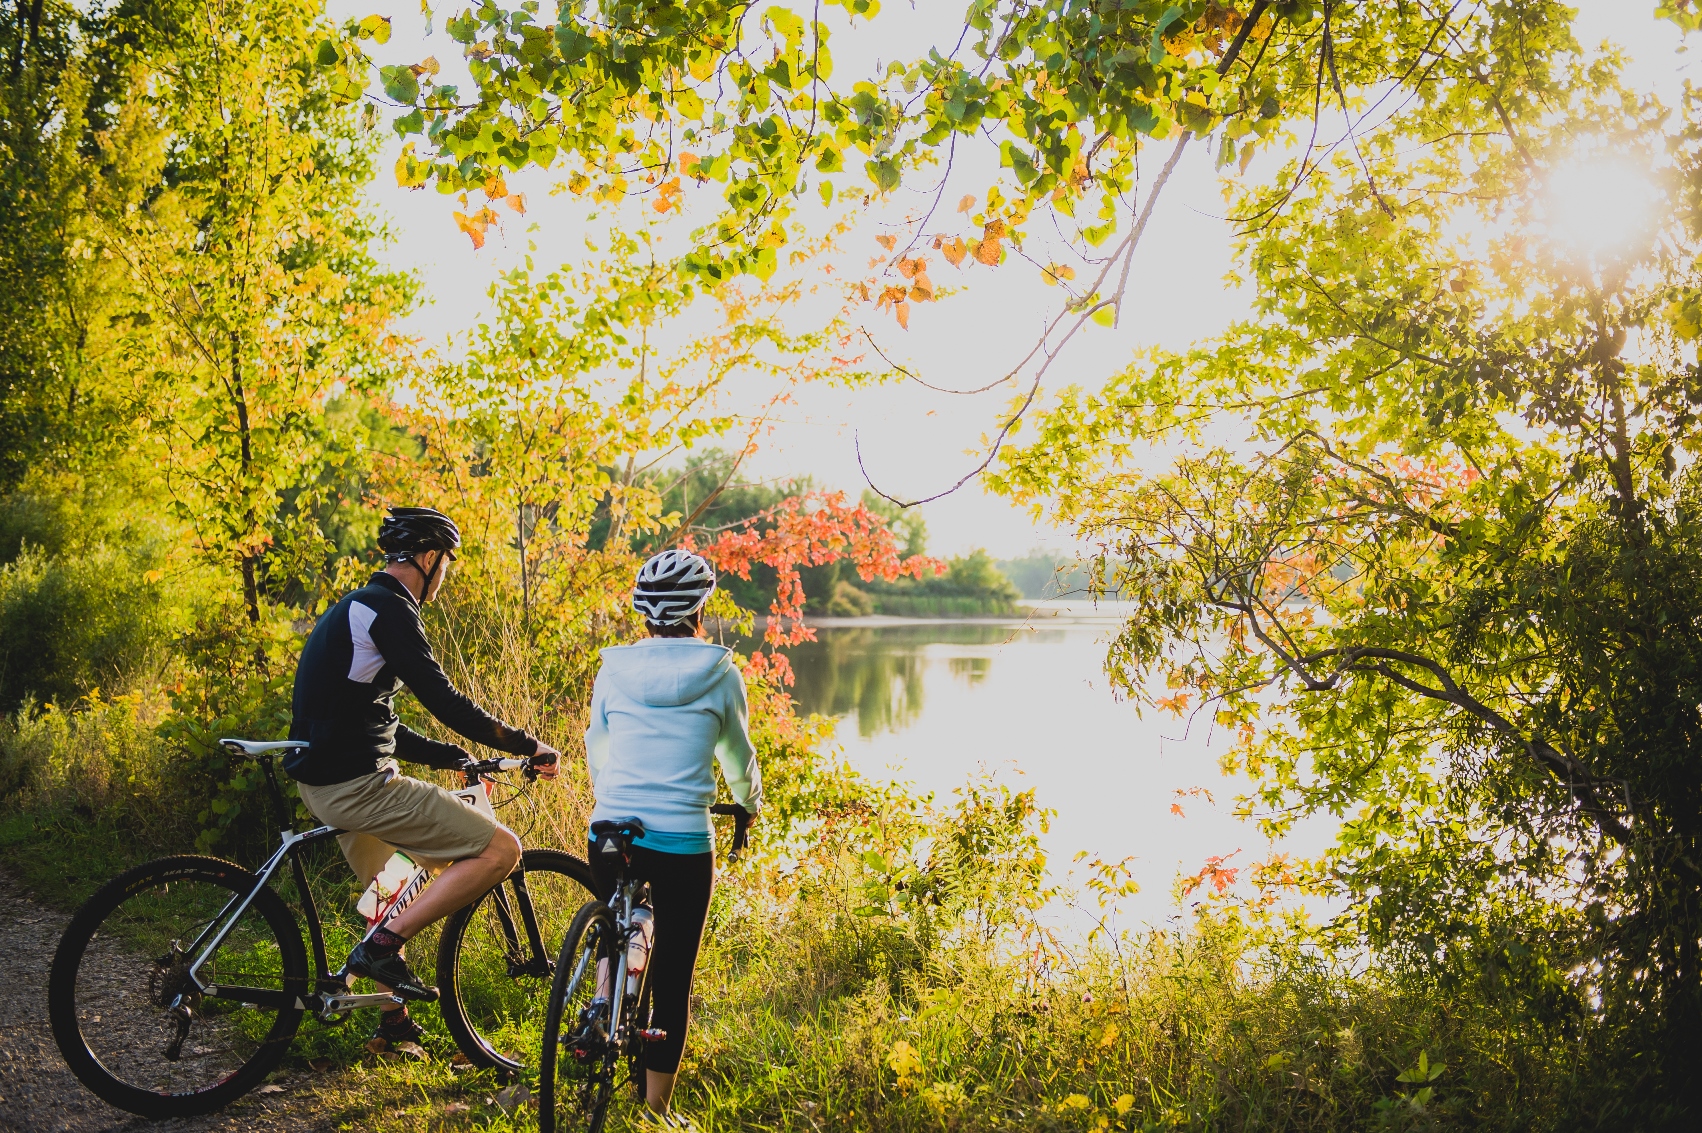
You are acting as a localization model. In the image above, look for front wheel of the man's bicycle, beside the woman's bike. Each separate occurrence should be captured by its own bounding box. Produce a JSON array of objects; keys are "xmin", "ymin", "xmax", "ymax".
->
[{"xmin": 437, "ymin": 849, "xmax": 591, "ymax": 1072}]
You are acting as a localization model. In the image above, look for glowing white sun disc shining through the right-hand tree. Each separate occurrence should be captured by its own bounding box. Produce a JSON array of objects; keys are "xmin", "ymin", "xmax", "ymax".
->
[{"xmin": 1542, "ymin": 153, "xmax": 1659, "ymax": 262}]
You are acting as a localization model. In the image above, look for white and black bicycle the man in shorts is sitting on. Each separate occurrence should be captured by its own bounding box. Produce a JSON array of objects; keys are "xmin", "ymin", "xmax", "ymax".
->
[{"xmin": 48, "ymin": 740, "xmax": 591, "ymax": 1118}]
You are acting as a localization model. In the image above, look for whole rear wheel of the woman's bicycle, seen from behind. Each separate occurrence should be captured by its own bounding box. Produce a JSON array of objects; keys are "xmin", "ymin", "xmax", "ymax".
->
[{"xmin": 538, "ymin": 902, "xmax": 621, "ymax": 1133}]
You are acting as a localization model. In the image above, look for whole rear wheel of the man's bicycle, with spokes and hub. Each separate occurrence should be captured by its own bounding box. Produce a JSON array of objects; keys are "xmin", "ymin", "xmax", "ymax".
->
[{"xmin": 48, "ymin": 856, "xmax": 308, "ymax": 1118}]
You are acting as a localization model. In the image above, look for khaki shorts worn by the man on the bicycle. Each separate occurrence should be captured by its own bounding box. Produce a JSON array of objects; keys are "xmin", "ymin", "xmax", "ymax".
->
[{"xmin": 296, "ymin": 764, "xmax": 502, "ymax": 888}]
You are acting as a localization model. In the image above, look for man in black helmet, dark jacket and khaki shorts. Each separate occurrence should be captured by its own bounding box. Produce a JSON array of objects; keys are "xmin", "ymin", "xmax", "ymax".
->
[{"xmin": 284, "ymin": 507, "xmax": 558, "ymax": 1043}]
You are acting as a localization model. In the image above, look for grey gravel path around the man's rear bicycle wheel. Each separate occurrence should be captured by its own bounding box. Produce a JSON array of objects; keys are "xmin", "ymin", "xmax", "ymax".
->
[{"xmin": 0, "ymin": 873, "xmax": 337, "ymax": 1133}]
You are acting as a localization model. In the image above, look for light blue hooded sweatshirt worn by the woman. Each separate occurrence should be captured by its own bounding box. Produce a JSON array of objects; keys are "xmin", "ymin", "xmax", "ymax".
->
[{"xmin": 585, "ymin": 638, "xmax": 762, "ymax": 854}]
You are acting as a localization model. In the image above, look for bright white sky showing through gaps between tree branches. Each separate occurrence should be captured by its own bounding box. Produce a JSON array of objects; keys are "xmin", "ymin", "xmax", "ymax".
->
[{"xmin": 330, "ymin": 0, "xmax": 1693, "ymax": 556}]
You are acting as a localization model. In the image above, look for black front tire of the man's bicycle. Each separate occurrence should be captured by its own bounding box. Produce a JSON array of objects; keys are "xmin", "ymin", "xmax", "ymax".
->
[{"xmin": 437, "ymin": 849, "xmax": 592, "ymax": 1073}]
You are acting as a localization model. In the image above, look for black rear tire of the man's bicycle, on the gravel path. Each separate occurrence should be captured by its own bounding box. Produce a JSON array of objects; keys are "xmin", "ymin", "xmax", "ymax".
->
[{"xmin": 48, "ymin": 854, "xmax": 308, "ymax": 1119}]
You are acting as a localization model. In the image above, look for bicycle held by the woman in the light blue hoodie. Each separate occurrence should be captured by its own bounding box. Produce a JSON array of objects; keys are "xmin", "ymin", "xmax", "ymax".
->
[{"xmin": 538, "ymin": 803, "xmax": 751, "ymax": 1133}]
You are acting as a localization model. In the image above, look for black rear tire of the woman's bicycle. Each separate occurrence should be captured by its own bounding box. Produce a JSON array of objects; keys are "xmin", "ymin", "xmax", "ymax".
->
[{"xmin": 538, "ymin": 900, "xmax": 620, "ymax": 1133}]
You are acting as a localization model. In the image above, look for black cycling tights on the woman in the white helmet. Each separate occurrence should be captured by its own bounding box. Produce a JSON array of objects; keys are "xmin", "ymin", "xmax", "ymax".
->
[{"xmin": 589, "ymin": 845, "xmax": 715, "ymax": 1073}]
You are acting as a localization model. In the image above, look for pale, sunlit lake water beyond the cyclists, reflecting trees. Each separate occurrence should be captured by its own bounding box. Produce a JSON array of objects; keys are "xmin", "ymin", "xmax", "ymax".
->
[{"xmin": 765, "ymin": 602, "xmax": 1329, "ymax": 924}]
